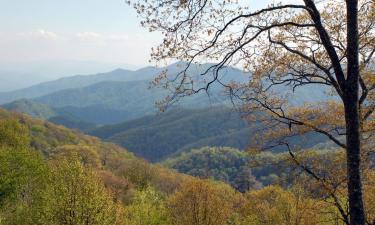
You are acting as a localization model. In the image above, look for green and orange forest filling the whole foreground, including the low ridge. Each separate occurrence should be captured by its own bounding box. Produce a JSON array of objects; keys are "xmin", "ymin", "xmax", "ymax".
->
[{"xmin": 0, "ymin": 110, "xmax": 375, "ymax": 225}]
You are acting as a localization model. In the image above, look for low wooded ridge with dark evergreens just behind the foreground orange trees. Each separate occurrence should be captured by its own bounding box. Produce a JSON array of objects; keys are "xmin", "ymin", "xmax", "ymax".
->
[{"xmin": 161, "ymin": 147, "xmax": 337, "ymax": 192}]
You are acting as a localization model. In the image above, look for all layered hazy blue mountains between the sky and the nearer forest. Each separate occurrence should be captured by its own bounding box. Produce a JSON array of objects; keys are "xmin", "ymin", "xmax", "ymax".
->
[{"xmin": 0, "ymin": 63, "xmax": 327, "ymax": 161}]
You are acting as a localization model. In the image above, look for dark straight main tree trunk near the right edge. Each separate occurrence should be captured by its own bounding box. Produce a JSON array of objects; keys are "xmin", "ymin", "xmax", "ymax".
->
[{"xmin": 344, "ymin": 0, "xmax": 365, "ymax": 225}]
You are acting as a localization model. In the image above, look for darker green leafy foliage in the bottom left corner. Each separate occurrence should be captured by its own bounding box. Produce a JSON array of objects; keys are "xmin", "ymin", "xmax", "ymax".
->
[{"xmin": 0, "ymin": 148, "xmax": 49, "ymax": 225}]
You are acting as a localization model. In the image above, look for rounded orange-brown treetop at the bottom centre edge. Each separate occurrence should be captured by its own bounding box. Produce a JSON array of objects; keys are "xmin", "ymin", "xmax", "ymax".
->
[{"xmin": 168, "ymin": 180, "xmax": 238, "ymax": 225}]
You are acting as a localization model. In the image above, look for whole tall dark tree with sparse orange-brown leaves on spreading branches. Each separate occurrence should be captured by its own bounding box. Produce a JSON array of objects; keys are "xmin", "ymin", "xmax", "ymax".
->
[{"xmin": 129, "ymin": 0, "xmax": 375, "ymax": 225}]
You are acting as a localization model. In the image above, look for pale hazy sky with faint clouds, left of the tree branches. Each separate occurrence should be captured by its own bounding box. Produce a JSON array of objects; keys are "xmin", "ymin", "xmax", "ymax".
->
[{"xmin": 0, "ymin": 0, "xmax": 300, "ymax": 72}]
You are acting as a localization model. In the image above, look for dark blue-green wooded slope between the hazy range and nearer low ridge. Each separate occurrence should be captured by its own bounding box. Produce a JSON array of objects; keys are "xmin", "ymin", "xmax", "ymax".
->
[{"xmin": 89, "ymin": 107, "xmax": 326, "ymax": 161}]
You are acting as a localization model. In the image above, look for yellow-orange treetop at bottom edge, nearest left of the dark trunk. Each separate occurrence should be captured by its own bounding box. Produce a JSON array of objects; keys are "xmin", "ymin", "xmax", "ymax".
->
[{"xmin": 242, "ymin": 186, "xmax": 324, "ymax": 225}]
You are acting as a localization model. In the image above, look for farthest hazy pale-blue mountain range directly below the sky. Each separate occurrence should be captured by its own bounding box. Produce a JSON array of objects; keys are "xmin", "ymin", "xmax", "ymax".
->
[{"xmin": 0, "ymin": 64, "xmax": 246, "ymax": 125}]
